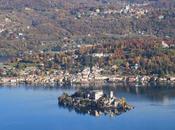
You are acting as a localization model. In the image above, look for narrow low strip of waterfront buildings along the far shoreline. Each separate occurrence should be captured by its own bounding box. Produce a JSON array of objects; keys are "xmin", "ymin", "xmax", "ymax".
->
[{"xmin": 0, "ymin": 76, "xmax": 175, "ymax": 88}]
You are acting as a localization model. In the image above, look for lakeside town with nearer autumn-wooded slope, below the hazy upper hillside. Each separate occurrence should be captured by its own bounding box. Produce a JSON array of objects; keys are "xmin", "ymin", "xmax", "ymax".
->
[{"xmin": 0, "ymin": 39, "xmax": 175, "ymax": 86}]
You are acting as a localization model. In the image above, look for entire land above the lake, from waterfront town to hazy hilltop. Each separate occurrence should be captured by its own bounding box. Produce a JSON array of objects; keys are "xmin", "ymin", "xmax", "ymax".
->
[{"xmin": 0, "ymin": 0, "xmax": 175, "ymax": 86}]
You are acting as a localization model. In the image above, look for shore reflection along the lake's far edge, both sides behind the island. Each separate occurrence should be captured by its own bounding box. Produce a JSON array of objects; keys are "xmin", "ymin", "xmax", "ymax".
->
[{"xmin": 0, "ymin": 84, "xmax": 175, "ymax": 103}]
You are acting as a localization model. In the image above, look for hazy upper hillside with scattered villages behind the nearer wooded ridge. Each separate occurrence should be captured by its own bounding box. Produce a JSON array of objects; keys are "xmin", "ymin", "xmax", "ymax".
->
[{"xmin": 0, "ymin": 0, "xmax": 175, "ymax": 55}]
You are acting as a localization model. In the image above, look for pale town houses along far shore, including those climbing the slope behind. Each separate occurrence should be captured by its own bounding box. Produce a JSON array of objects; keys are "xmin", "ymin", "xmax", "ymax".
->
[{"xmin": 0, "ymin": 66, "xmax": 175, "ymax": 85}]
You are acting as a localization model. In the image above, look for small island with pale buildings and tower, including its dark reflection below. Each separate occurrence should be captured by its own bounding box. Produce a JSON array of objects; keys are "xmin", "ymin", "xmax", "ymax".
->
[{"xmin": 58, "ymin": 90, "xmax": 134, "ymax": 116}]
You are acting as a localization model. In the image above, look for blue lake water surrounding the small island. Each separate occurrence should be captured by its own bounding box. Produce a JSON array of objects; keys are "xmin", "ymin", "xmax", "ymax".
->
[{"xmin": 0, "ymin": 86, "xmax": 175, "ymax": 130}]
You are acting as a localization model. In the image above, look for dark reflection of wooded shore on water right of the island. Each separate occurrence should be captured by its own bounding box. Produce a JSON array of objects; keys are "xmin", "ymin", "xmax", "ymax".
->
[{"xmin": 105, "ymin": 86, "xmax": 175, "ymax": 102}]
